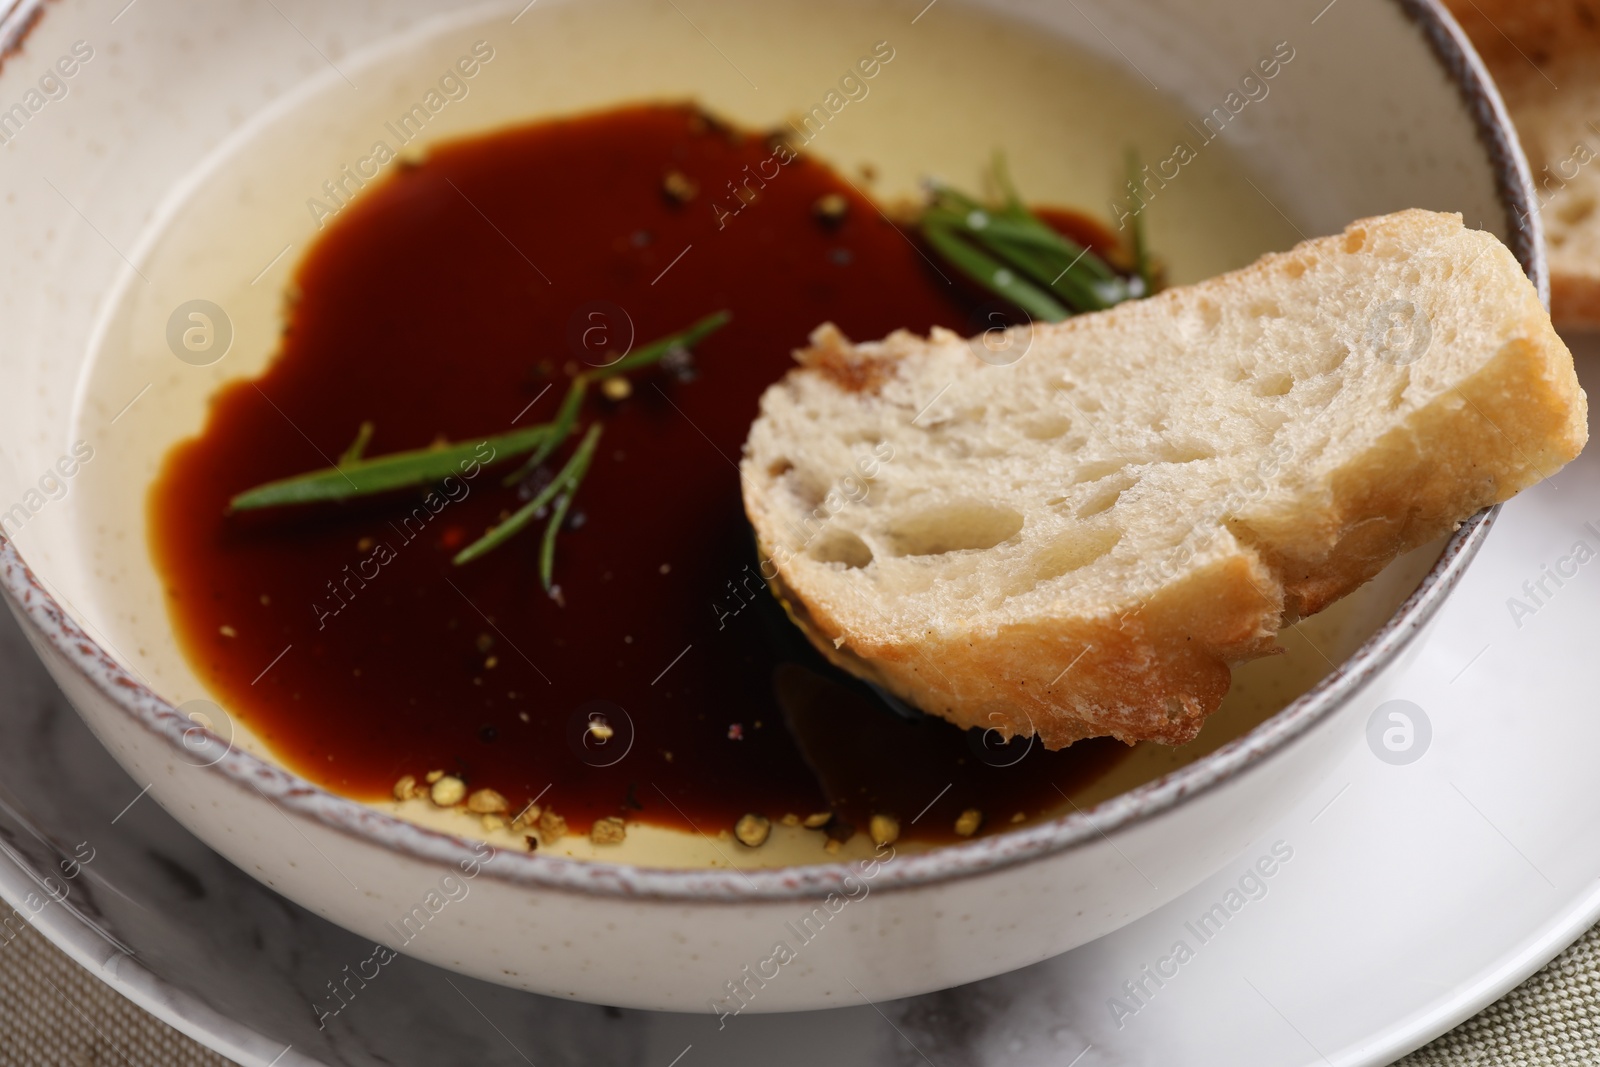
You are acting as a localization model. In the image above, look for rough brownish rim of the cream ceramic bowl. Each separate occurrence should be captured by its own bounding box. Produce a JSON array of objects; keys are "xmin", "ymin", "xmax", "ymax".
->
[{"xmin": 0, "ymin": 0, "xmax": 1549, "ymax": 902}]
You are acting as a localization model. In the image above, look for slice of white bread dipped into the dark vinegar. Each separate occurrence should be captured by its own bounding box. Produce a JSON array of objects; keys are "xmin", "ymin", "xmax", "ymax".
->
[{"xmin": 741, "ymin": 211, "xmax": 1587, "ymax": 749}]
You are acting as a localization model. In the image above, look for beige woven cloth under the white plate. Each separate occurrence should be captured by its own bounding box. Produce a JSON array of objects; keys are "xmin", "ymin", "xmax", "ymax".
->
[{"xmin": 0, "ymin": 926, "xmax": 1600, "ymax": 1067}]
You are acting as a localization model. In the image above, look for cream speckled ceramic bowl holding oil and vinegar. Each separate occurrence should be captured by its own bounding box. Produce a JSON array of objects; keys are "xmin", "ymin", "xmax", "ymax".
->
[{"xmin": 0, "ymin": 0, "xmax": 1546, "ymax": 1013}]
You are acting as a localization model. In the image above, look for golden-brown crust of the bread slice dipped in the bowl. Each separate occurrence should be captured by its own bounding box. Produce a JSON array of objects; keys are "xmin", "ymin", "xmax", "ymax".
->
[{"xmin": 741, "ymin": 211, "xmax": 1587, "ymax": 749}]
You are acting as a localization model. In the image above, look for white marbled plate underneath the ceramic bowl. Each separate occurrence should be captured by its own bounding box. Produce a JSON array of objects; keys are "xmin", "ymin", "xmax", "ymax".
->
[{"xmin": 0, "ymin": 347, "xmax": 1600, "ymax": 1067}]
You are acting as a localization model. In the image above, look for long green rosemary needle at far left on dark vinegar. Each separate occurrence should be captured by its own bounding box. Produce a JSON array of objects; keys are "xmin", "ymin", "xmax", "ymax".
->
[{"xmin": 229, "ymin": 426, "xmax": 550, "ymax": 512}]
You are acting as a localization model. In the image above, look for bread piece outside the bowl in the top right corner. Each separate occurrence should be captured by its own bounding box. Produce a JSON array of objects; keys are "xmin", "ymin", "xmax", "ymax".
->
[{"xmin": 1446, "ymin": 0, "xmax": 1600, "ymax": 326}]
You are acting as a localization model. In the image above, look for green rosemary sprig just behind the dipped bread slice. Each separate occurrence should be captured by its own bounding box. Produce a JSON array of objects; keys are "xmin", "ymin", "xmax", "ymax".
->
[{"xmin": 922, "ymin": 155, "xmax": 1149, "ymax": 322}]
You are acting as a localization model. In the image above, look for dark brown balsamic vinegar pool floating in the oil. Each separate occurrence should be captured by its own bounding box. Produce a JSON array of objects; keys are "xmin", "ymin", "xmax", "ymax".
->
[{"xmin": 150, "ymin": 107, "xmax": 1123, "ymax": 840}]
